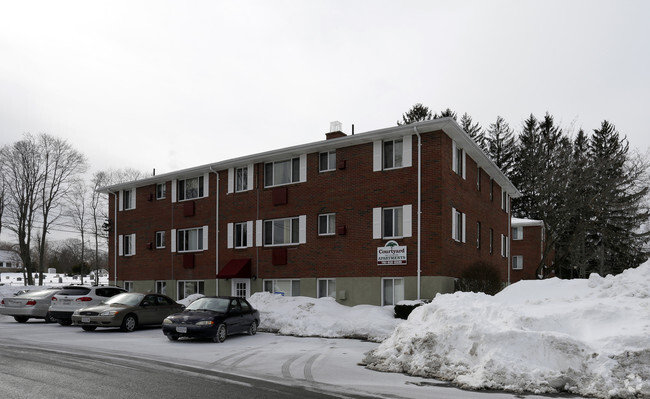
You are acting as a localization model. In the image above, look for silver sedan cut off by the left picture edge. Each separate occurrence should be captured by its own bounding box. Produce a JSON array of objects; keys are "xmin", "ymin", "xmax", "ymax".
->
[{"xmin": 0, "ymin": 288, "xmax": 61, "ymax": 323}]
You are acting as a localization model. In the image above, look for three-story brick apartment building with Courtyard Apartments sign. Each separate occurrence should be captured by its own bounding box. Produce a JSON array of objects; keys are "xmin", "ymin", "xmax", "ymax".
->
[{"xmin": 101, "ymin": 118, "xmax": 520, "ymax": 305}]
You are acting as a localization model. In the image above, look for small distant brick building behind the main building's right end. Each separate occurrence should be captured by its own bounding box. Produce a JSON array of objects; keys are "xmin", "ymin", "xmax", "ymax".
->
[{"xmin": 510, "ymin": 217, "xmax": 553, "ymax": 283}]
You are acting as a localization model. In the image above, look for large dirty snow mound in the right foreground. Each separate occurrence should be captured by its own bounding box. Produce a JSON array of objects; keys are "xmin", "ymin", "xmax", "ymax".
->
[{"xmin": 365, "ymin": 263, "xmax": 650, "ymax": 398}]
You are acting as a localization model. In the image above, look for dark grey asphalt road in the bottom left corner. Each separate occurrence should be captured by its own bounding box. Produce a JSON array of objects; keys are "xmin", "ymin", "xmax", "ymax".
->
[{"xmin": 0, "ymin": 344, "xmax": 360, "ymax": 399}]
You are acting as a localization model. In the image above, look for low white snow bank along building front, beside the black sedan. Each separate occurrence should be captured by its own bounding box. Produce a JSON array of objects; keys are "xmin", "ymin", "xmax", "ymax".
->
[{"xmin": 249, "ymin": 292, "xmax": 403, "ymax": 342}]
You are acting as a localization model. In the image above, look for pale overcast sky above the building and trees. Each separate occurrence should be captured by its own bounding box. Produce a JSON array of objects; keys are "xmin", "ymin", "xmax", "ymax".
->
[{"xmin": 0, "ymin": 0, "xmax": 650, "ymax": 177}]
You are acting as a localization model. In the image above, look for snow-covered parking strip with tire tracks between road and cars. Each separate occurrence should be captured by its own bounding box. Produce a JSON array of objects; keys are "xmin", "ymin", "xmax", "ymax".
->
[{"xmin": 0, "ymin": 316, "xmax": 566, "ymax": 399}]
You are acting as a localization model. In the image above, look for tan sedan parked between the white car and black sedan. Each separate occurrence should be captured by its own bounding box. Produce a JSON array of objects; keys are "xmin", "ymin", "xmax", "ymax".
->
[{"xmin": 72, "ymin": 292, "xmax": 184, "ymax": 332}]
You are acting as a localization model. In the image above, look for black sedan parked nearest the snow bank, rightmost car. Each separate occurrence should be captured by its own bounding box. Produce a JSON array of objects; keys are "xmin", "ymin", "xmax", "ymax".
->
[{"xmin": 162, "ymin": 297, "xmax": 260, "ymax": 342}]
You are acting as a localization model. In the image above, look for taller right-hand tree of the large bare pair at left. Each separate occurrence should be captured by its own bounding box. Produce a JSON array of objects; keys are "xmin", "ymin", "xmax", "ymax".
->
[{"xmin": 38, "ymin": 133, "xmax": 86, "ymax": 285}]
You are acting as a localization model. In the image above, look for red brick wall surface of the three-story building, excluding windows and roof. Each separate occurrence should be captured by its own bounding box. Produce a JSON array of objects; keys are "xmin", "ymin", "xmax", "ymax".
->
[{"xmin": 109, "ymin": 131, "xmax": 507, "ymax": 281}]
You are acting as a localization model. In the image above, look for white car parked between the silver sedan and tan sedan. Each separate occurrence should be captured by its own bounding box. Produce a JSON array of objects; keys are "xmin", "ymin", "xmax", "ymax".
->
[{"xmin": 50, "ymin": 285, "xmax": 126, "ymax": 326}]
